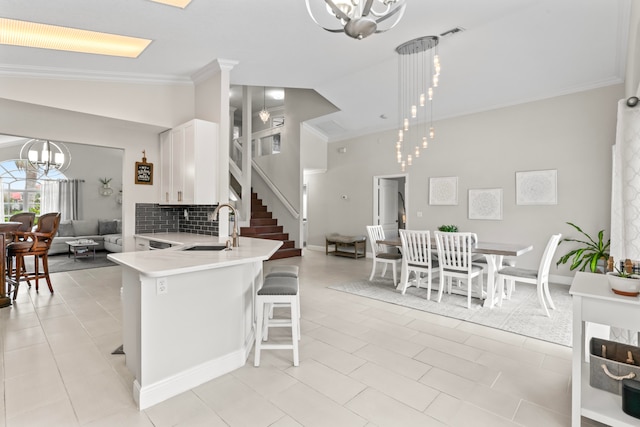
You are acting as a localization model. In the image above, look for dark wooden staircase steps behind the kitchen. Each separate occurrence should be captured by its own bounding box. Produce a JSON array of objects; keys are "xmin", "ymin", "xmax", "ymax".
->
[{"xmin": 240, "ymin": 192, "xmax": 302, "ymax": 260}]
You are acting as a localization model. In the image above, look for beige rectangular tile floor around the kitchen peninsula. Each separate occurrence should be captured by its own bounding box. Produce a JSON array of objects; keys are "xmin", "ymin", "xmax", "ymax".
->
[{"xmin": 0, "ymin": 251, "xmax": 595, "ymax": 427}]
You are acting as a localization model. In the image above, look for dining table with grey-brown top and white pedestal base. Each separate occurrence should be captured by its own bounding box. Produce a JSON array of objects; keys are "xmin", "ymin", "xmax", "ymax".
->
[{"xmin": 376, "ymin": 237, "xmax": 533, "ymax": 308}]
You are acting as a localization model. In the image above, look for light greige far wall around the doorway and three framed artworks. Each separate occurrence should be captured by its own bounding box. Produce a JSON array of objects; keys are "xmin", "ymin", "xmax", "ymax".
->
[{"xmin": 308, "ymin": 85, "xmax": 624, "ymax": 282}]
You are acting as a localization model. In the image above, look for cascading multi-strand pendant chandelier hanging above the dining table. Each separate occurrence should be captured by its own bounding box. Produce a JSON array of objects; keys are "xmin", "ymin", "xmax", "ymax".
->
[{"xmin": 396, "ymin": 36, "xmax": 440, "ymax": 171}]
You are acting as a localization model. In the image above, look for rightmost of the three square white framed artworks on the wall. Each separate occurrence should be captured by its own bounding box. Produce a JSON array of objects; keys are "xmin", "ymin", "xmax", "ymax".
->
[{"xmin": 516, "ymin": 169, "xmax": 558, "ymax": 205}]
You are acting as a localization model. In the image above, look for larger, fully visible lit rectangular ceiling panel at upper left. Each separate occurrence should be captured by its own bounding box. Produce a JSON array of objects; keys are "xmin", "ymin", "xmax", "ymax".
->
[{"xmin": 0, "ymin": 18, "xmax": 151, "ymax": 58}]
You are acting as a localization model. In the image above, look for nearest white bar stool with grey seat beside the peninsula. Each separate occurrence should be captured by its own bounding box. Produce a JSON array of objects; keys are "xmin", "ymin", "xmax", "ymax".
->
[{"xmin": 253, "ymin": 276, "xmax": 300, "ymax": 366}]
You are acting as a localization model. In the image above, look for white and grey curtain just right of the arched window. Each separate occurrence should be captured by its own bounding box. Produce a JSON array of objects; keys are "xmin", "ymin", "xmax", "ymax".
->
[{"xmin": 40, "ymin": 179, "xmax": 84, "ymax": 221}]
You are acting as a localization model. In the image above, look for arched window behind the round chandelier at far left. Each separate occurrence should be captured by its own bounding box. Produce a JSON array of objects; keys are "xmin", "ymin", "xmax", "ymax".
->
[{"xmin": 0, "ymin": 160, "xmax": 66, "ymax": 221}]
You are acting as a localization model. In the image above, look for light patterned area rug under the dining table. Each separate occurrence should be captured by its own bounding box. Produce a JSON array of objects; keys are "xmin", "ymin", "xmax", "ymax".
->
[{"xmin": 329, "ymin": 278, "xmax": 572, "ymax": 347}]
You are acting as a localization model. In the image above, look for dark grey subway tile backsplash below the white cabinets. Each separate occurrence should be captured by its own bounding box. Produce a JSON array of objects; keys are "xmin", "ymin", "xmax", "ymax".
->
[{"xmin": 136, "ymin": 203, "xmax": 218, "ymax": 236}]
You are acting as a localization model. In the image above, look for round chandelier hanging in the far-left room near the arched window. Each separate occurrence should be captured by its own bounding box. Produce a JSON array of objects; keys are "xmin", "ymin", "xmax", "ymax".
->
[{"xmin": 20, "ymin": 139, "xmax": 71, "ymax": 175}]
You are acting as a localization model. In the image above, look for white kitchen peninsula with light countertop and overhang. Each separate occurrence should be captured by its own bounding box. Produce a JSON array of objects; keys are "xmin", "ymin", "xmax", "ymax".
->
[{"xmin": 108, "ymin": 233, "xmax": 282, "ymax": 410}]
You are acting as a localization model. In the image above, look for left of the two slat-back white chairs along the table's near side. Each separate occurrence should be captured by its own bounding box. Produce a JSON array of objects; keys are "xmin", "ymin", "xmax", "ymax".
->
[{"xmin": 400, "ymin": 230, "xmax": 438, "ymax": 300}]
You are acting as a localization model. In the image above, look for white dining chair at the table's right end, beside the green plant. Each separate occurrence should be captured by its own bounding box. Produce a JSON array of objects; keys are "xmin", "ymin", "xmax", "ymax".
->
[{"xmin": 497, "ymin": 234, "xmax": 562, "ymax": 317}]
